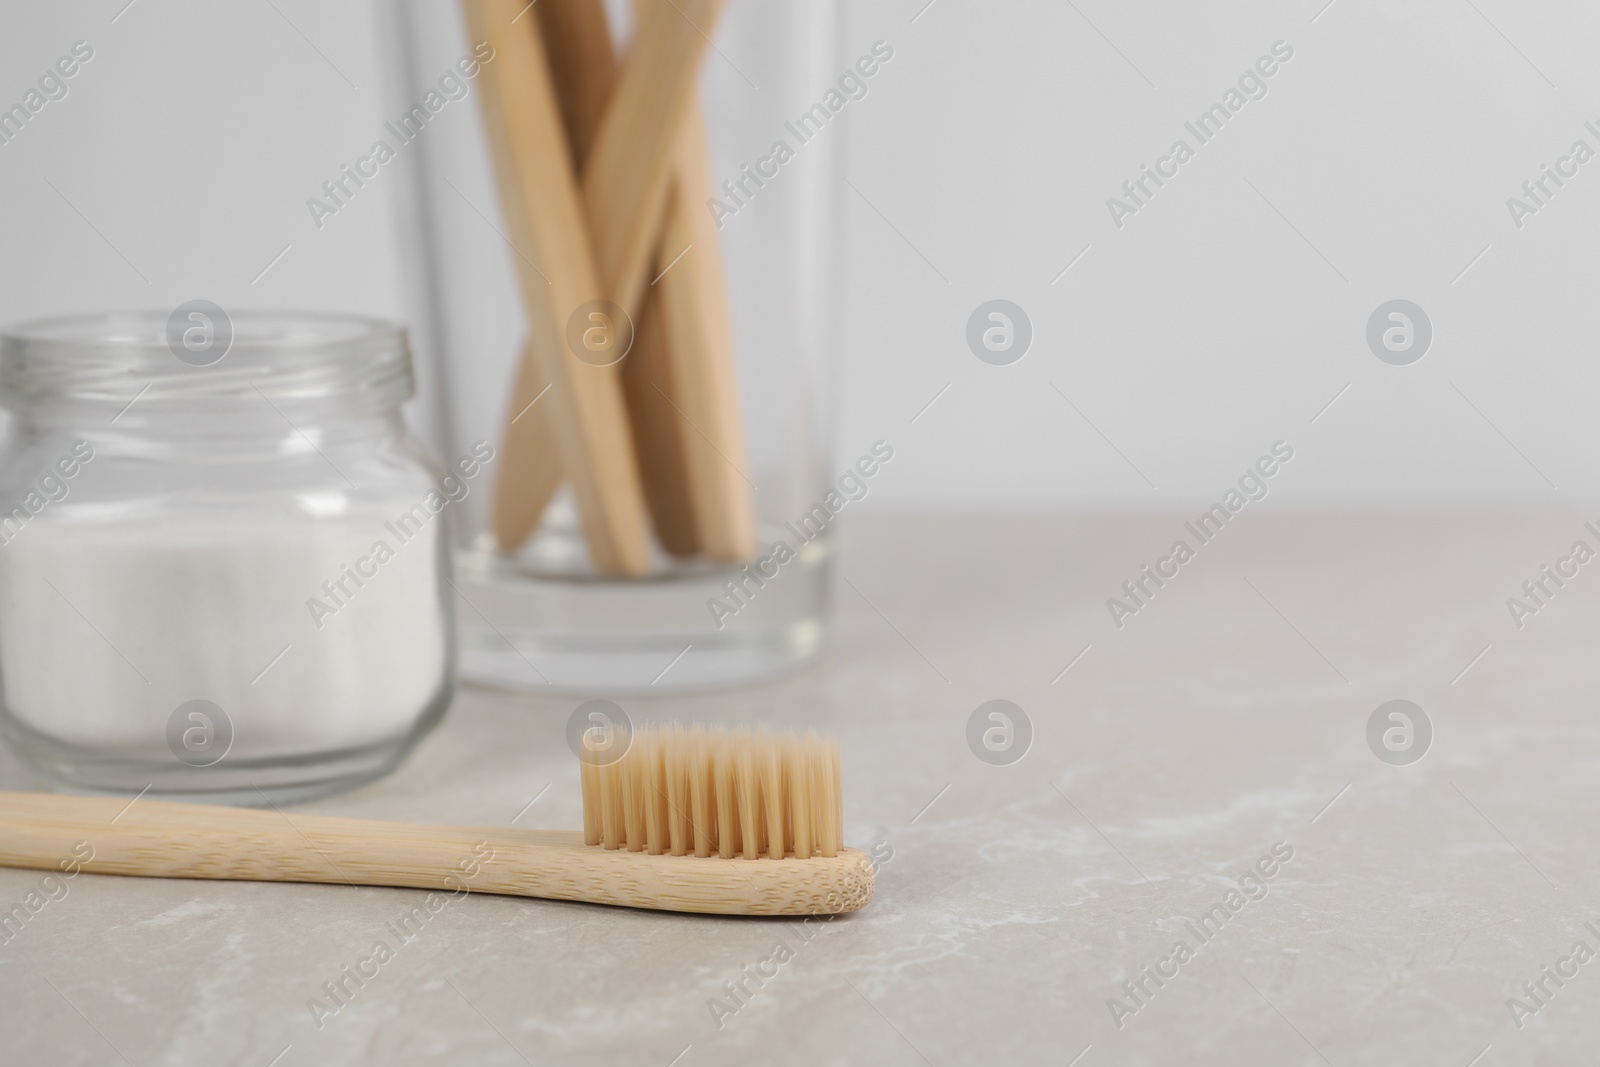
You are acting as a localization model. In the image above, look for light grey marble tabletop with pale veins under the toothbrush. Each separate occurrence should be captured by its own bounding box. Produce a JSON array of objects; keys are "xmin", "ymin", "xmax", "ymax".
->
[{"xmin": 0, "ymin": 512, "xmax": 1600, "ymax": 1067}]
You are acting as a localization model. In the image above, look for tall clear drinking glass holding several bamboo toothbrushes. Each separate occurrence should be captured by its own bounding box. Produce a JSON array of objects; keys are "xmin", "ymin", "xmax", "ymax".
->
[{"xmin": 384, "ymin": 0, "xmax": 864, "ymax": 693}]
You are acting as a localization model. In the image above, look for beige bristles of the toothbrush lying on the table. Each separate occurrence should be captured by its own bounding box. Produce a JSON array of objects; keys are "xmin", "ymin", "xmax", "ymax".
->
[{"xmin": 579, "ymin": 723, "xmax": 843, "ymax": 859}]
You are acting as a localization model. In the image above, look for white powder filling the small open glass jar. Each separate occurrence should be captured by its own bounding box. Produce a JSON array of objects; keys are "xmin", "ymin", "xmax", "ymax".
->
[{"xmin": 0, "ymin": 501, "xmax": 448, "ymax": 760}]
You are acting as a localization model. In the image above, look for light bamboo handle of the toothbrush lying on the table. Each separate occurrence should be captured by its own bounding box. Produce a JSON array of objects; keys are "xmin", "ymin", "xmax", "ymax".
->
[{"xmin": 0, "ymin": 792, "xmax": 872, "ymax": 915}]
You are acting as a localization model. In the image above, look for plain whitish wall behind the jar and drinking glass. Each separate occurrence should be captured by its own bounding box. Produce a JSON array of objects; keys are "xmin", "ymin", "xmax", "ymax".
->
[{"xmin": 0, "ymin": 0, "xmax": 1600, "ymax": 509}]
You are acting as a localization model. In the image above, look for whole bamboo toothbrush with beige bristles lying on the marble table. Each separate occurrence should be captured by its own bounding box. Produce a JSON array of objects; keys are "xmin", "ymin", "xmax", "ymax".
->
[{"xmin": 0, "ymin": 726, "xmax": 874, "ymax": 915}]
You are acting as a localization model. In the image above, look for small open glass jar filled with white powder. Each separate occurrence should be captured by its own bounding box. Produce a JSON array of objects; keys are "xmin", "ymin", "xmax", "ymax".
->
[{"xmin": 0, "ymin": 308, "xmax": 457, "ymax": 805}]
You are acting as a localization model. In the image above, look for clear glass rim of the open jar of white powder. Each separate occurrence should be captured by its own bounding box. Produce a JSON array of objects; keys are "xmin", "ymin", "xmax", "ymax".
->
[{"xmin": 0, "ymin": 310, "xmax": 414, "ymax": 408}]
